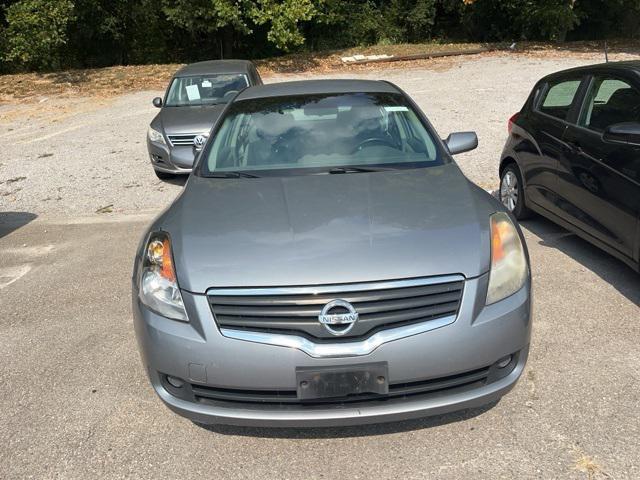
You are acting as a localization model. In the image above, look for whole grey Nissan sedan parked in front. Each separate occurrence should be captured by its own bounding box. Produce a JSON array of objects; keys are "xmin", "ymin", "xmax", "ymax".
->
[{"xmin": 133, "ymin": 80, "xmax": 531, "ymax": 427}]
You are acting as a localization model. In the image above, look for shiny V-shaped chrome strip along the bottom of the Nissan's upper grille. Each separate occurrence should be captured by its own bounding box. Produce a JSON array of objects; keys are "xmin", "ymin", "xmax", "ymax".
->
[{"xmin": 220, "ymin": 315, "xmax": 456, "ymax": 358}]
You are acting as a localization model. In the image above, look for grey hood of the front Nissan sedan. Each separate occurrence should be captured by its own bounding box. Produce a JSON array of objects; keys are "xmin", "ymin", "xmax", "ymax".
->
[{"xmin": 157, "ymin": 164, "xmax": 497, "ymax": 293}]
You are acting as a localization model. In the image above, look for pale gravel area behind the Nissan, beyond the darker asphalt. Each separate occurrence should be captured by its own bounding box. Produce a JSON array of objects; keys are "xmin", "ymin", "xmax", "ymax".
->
[{"xmin": 0, "ymin": 55, "xmax": 632, "ymax": 216}]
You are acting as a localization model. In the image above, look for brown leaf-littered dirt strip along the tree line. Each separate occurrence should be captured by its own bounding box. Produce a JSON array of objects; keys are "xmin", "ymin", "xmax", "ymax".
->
[{"xmin": 0, "ymin": 41, "xmax": 640, "ymax": 104}]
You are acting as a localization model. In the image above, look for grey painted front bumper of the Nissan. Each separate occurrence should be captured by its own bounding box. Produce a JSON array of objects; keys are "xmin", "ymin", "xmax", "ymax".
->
[{"xmin": 133, "ymin": 275, "xmax": 531, "ymax": 427}]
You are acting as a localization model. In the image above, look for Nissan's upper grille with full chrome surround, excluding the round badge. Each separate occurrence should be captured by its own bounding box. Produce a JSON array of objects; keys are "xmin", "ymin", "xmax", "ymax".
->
[{"xmin": 206, "ymin": 275, "xmax": 465, "ymax": 350}]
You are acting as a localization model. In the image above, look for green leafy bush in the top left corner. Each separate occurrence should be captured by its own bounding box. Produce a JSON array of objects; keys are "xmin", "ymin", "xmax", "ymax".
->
[{"xmin": 3, "ymin": 0, "xmax": 74, "ymax": 70}]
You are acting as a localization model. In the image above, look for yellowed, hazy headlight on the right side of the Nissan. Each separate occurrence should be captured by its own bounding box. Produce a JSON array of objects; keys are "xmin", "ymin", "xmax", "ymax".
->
[{"xmin": 487, "ymin": 212, "xmax": 529, "ymax": 305}]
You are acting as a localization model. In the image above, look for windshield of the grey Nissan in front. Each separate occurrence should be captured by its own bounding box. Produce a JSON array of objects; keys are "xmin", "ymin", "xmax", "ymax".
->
[{"xmin": 202, "ymin": 93, "xmax": 446, "ymax": 176}]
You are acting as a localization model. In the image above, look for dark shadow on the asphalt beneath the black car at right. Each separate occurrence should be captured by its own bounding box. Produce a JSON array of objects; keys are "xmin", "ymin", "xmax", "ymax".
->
[{"xmin": 522, "ymin": 217, "xmax": 640, "ymax": 306}]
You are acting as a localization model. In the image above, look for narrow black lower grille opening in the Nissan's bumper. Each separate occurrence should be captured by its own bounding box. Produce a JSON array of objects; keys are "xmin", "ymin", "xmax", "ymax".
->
[{"xmin": 190, "ymin": 367, "xmax": 490, "ymax": 405}]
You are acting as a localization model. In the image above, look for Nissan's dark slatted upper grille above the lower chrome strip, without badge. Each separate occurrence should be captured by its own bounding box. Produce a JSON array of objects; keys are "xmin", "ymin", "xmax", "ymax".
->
[{"xmin": 208, "ymin": 276, "xmax": 464, "ymax": 342}]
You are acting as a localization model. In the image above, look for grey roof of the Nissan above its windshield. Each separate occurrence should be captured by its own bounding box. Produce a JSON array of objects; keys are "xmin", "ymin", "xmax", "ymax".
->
[{"xmin": 236, "ymin": 80, "xmax": 401, "ymax": 101}]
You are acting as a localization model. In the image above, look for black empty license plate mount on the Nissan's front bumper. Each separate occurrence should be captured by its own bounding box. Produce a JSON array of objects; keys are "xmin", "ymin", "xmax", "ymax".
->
[{"xmin": 296, "ymin": 362, "xmax": 389, "ymax": 400}]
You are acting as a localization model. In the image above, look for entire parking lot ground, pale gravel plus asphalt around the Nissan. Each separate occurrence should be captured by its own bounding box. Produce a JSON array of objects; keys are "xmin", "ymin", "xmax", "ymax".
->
[{"xmin": 0, "ymin": 50, "xmax": 640, "ymax": 479}]
